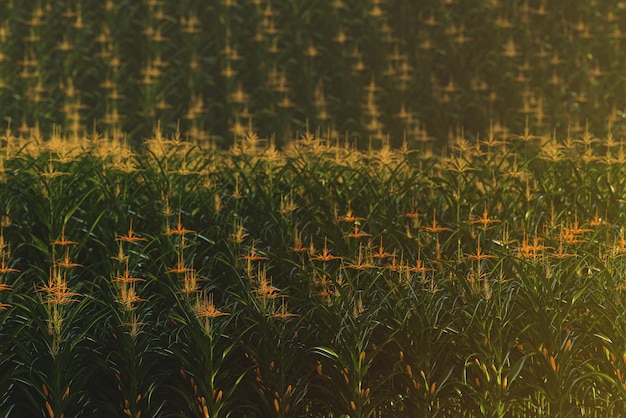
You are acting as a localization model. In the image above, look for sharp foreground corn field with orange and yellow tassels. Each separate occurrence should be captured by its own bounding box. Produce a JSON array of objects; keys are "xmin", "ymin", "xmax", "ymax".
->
[{"xmin": 0, "ymin": 131, "xmax": 626, "ymax": 417}]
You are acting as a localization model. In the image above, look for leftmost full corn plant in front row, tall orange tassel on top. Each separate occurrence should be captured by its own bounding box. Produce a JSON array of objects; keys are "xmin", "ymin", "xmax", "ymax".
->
[{"xmin": 9, "ymin": 235, "xmax": 102, "ymax": 417}]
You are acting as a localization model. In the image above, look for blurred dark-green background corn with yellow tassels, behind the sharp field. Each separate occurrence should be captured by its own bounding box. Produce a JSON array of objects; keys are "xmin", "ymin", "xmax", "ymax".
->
[{"xmin": 0, "ymin": 0, "xmax": 626, "ymax": 147}]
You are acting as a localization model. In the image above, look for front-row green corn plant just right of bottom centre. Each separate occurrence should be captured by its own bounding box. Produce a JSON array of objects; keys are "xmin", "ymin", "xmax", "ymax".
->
[{"xmin": 312, "ymin": 261, "xmax": 400, "ymax": 417}]
